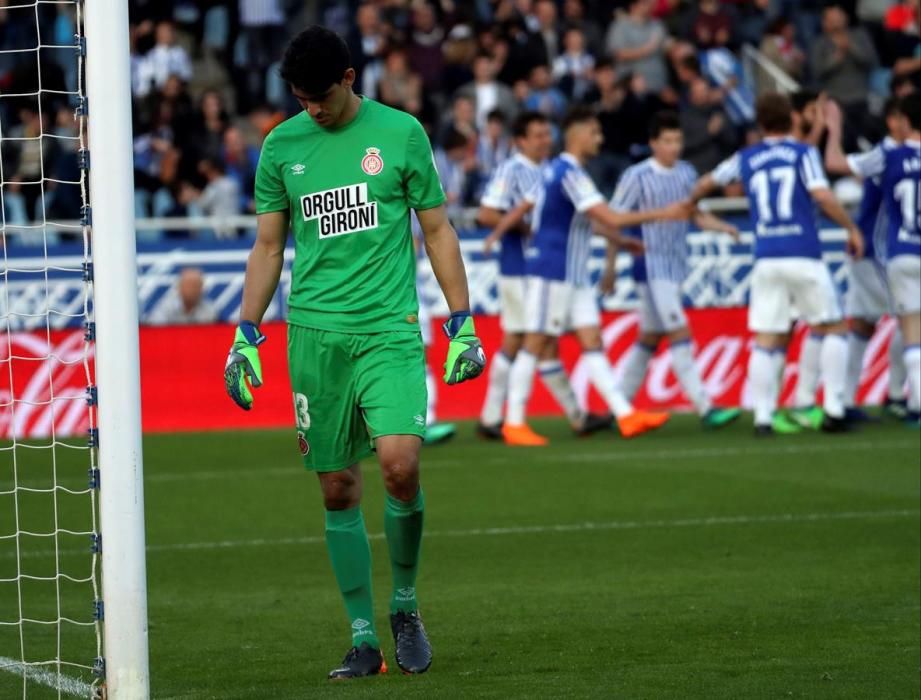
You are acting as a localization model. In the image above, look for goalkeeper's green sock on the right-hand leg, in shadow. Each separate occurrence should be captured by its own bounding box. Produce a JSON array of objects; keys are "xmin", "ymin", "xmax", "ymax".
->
[{"xmin": 384, "ymin": 488, "xmax": 425, "ymax": 613}]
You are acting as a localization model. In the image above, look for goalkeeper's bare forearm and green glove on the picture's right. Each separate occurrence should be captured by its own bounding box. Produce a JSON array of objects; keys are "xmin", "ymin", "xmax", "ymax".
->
[{"xmin": 416, "ymin": 205, "xmax": 486, "ymax": 384}]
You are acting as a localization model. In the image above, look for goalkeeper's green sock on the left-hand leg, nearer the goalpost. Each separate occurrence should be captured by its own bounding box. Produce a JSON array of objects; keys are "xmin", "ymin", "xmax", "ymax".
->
[{"xmin": 326, "ymin": 507, "xmax": 381, "ymax": 649}]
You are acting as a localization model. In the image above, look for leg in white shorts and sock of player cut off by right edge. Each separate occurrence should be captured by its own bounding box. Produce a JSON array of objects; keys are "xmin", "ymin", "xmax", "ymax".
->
[{"xmin": 887, "ymin": 255, "xmax": 921, "ymax": 427}]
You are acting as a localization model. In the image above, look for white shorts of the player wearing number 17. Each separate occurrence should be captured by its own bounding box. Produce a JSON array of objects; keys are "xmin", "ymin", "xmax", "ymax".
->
[{"xmin": 748, "ymin": 258, "xmax": 844, "ymax": 333}]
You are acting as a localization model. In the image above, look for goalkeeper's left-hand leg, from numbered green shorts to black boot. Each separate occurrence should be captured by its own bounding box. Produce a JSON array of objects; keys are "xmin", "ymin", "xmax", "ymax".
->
[{"xmin": 288, "ymin": 326, "xmax": 383, "ymax": 678}]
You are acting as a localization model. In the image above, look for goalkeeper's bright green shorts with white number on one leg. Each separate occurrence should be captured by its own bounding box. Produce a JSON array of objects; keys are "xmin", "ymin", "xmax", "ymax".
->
[{"xmin": 288, "ymin": 325, "xmax": 428, "ymax": 472}]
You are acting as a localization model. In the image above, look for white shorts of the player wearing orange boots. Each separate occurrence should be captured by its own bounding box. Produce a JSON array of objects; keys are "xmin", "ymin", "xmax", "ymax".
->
[{"xmin": 525, "ymin": 277, "xmax": 601, "ymax": 336}]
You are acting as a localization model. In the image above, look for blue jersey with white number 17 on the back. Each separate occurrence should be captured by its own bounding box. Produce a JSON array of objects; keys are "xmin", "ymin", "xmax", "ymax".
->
[{"xmin": 713, "ymin": 136, "xmax": 828, "ymax": 260}]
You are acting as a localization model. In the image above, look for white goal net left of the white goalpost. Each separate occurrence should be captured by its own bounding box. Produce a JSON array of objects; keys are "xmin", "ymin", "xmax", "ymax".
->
[{"xmin": 0, "ymin": 0, "xmax": 146, "ymax": 698}]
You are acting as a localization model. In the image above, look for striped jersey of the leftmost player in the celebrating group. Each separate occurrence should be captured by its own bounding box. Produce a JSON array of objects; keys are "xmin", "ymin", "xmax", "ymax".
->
[{"xmin": 480, "ymin": 153, "xmax": 541, "ymax": 277}]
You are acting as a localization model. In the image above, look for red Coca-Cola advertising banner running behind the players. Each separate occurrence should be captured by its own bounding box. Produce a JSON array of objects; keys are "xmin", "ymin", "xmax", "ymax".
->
[{"xmin": 0, "ymin": 309, "xmax": 894, "ymax": 440}]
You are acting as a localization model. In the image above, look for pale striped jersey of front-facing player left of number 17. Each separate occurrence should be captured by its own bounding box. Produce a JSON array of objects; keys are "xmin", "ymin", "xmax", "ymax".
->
[{"xmin": 611, "ymin": 158, "xmax": 697, "ymax": 283}]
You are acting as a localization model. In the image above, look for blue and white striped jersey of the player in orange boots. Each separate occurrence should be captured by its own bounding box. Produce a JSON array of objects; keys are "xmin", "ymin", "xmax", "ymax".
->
[{"xmin": 525, "ymin": 153, "xmax": 604, "ymax": 287}]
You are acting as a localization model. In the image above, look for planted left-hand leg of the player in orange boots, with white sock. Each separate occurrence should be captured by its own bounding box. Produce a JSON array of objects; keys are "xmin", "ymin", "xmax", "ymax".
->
[{"xmin": 502, "ymin": 277, "xmax": 572, "ymax": 447}]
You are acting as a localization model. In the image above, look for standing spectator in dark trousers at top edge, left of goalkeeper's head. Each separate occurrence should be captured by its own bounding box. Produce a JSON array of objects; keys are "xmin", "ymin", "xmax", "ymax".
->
[{"xmin": 234, "ymin": 0, "xmax": 285, "ymax": 111}]
